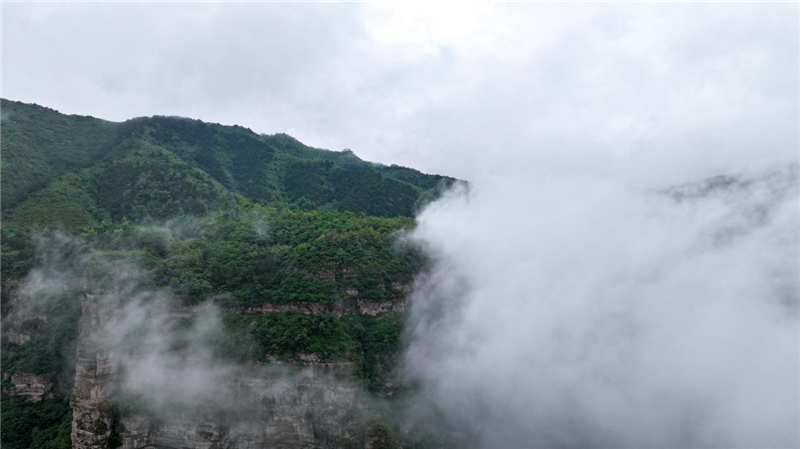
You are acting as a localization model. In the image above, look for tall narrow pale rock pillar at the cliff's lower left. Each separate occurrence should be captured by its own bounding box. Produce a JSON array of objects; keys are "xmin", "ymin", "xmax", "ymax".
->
[{"xmin": 72, "ymin": 294, "xmax": 117, "ymax": 449}]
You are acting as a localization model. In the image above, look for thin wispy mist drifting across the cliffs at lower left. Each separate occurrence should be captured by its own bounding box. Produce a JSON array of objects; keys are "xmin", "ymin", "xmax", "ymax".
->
[{"xmin": 3, "ymin": 224, "xmax": 366, "ymax": 438}]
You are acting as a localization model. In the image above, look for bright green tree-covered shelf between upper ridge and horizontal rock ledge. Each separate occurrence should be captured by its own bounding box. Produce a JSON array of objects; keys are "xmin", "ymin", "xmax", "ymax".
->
[{"xmin": 2, "ymin": 204, "xmax": 424, "ymax": 305}]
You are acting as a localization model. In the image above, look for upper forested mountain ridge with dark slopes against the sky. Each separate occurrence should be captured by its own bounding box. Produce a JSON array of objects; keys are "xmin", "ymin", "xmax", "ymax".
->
[{"xmin": 0, "ymin": 100, "xmax": 455, "ymax": 225}]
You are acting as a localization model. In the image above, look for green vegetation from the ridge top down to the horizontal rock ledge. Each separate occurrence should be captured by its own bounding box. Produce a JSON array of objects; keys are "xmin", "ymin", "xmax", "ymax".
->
[{"xmin": 1, "ymin": 96, "xmax": 438, "ymax": 304}]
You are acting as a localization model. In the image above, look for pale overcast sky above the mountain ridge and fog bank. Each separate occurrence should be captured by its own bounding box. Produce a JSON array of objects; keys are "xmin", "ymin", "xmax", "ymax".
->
[{"xmin": 2, "ymin": 2, "xmax": 798, "ymax": 186}]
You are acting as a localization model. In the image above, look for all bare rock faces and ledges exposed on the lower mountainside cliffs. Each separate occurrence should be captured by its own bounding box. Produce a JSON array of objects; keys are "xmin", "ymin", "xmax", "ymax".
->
[{"xmin": 3, "ymin": 274, "xmax": 406, "ymax": 449}]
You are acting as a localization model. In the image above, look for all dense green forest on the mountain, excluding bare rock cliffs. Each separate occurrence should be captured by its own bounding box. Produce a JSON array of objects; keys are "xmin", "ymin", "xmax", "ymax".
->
[{"xmin": 0, "ymin": 100, "xmax": 456, "ymax": 449}]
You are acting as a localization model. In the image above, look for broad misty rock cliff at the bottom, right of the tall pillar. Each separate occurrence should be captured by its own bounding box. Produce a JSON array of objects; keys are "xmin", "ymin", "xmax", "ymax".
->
[{"xmin": 122, "ymin": 364, "xmax": 361, "ymax": 449}]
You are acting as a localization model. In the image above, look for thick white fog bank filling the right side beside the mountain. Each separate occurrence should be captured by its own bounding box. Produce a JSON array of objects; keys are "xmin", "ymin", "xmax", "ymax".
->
[{"xmin": 405, "ymin": 165, "xmax": 800, "ymax": 448}]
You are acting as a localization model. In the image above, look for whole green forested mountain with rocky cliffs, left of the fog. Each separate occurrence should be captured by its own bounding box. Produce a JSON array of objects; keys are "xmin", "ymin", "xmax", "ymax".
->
[{"xmin": 0, "ymin": 100, "xmax": 456, "ymax": 449}]
